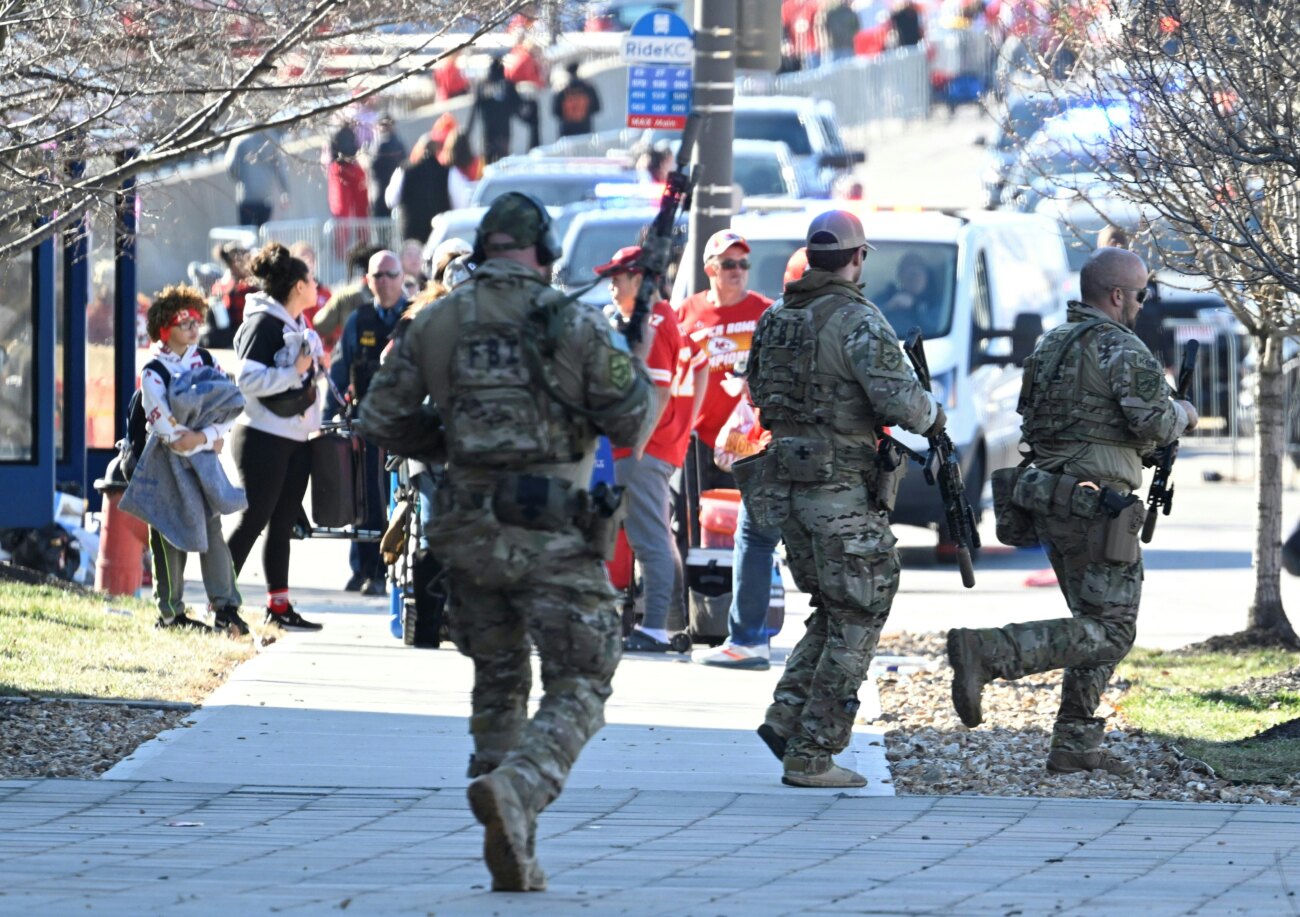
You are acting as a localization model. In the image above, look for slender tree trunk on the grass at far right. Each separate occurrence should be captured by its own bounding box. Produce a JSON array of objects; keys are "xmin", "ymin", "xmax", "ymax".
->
[{"xmin": 1247, "ymin": 334, "xmax": 1300, "ymax": 645}]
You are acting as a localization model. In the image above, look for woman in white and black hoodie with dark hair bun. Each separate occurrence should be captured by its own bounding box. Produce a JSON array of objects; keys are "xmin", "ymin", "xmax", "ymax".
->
[{"xmin": 229, "ymin": 242, "xmax": 324, "ymax": 631}]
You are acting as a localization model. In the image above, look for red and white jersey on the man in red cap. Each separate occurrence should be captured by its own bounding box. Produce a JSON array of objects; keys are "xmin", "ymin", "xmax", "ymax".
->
[{"xmin": 614, "ymin": 302, "xmax": 705, "ymax": 467}]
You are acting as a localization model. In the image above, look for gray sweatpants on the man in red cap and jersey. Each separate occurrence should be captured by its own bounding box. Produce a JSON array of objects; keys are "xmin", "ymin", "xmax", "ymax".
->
[{"xmin": 614, "ymin": 455, "xmax": 681, "ymax": 630}]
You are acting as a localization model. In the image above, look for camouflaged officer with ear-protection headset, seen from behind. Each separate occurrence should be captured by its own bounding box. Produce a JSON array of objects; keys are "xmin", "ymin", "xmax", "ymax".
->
[{"xmin": 360, "ymin": 193, "xmax": 651, "ymax": 891}]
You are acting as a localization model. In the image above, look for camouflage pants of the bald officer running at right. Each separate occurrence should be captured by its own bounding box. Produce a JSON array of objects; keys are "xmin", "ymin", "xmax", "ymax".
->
[{"xmin": 979, "ymin": 512, "xmax": 1143, "ymax": 752}]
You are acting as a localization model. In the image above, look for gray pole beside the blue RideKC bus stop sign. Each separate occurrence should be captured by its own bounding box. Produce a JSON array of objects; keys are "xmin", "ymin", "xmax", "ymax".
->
[{"xmin": 681, "ymin": 0, "xmax": 738, "ymax": 293}]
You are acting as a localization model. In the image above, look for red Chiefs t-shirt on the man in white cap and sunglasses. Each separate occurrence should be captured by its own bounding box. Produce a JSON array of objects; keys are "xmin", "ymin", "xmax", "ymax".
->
[{"xmin": 677, "ymin": 290, "xmax": 772, "ymax": 449}]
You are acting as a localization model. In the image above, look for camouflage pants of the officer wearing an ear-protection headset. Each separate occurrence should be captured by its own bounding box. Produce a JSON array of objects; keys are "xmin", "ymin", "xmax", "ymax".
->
[{"xmin": 439, "ymin": 507, "xmax": 623, "ymax": 812}]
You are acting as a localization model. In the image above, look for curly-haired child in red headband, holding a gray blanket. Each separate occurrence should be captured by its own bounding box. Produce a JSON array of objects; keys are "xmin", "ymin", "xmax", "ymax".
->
[{"xmin": 140, "ymin": 285, "xmax": 248, "ymax": 636}]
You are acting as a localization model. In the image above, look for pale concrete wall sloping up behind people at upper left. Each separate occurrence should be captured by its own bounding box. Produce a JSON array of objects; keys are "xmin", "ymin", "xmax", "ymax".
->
[{"xmin": 138, "ymin": 59, "xmax": 628, "ymax": 294}]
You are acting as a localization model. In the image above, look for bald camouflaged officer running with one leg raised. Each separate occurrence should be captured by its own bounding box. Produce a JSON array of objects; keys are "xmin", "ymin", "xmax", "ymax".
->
[{"xmin": 948, "ymin": 248, "xmax": 1197, "ymax": 775}]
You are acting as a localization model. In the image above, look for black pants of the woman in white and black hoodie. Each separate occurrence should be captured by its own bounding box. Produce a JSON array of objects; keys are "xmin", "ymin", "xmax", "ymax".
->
[{"xmin": 229, "ymin": 424, "xmax": 312, "ymax": 591}]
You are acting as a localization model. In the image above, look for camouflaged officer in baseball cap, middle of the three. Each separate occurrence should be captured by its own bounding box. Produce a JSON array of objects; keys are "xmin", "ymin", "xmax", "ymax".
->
[{"xmin": 735, "ymin": 211, "xmax": 944, "ymax": 787}]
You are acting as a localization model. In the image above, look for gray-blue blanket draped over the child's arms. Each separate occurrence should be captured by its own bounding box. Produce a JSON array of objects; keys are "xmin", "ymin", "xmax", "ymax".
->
[{"xmin": 121, "ymin": 367, "xmax": 248, "ymax": 554}]
